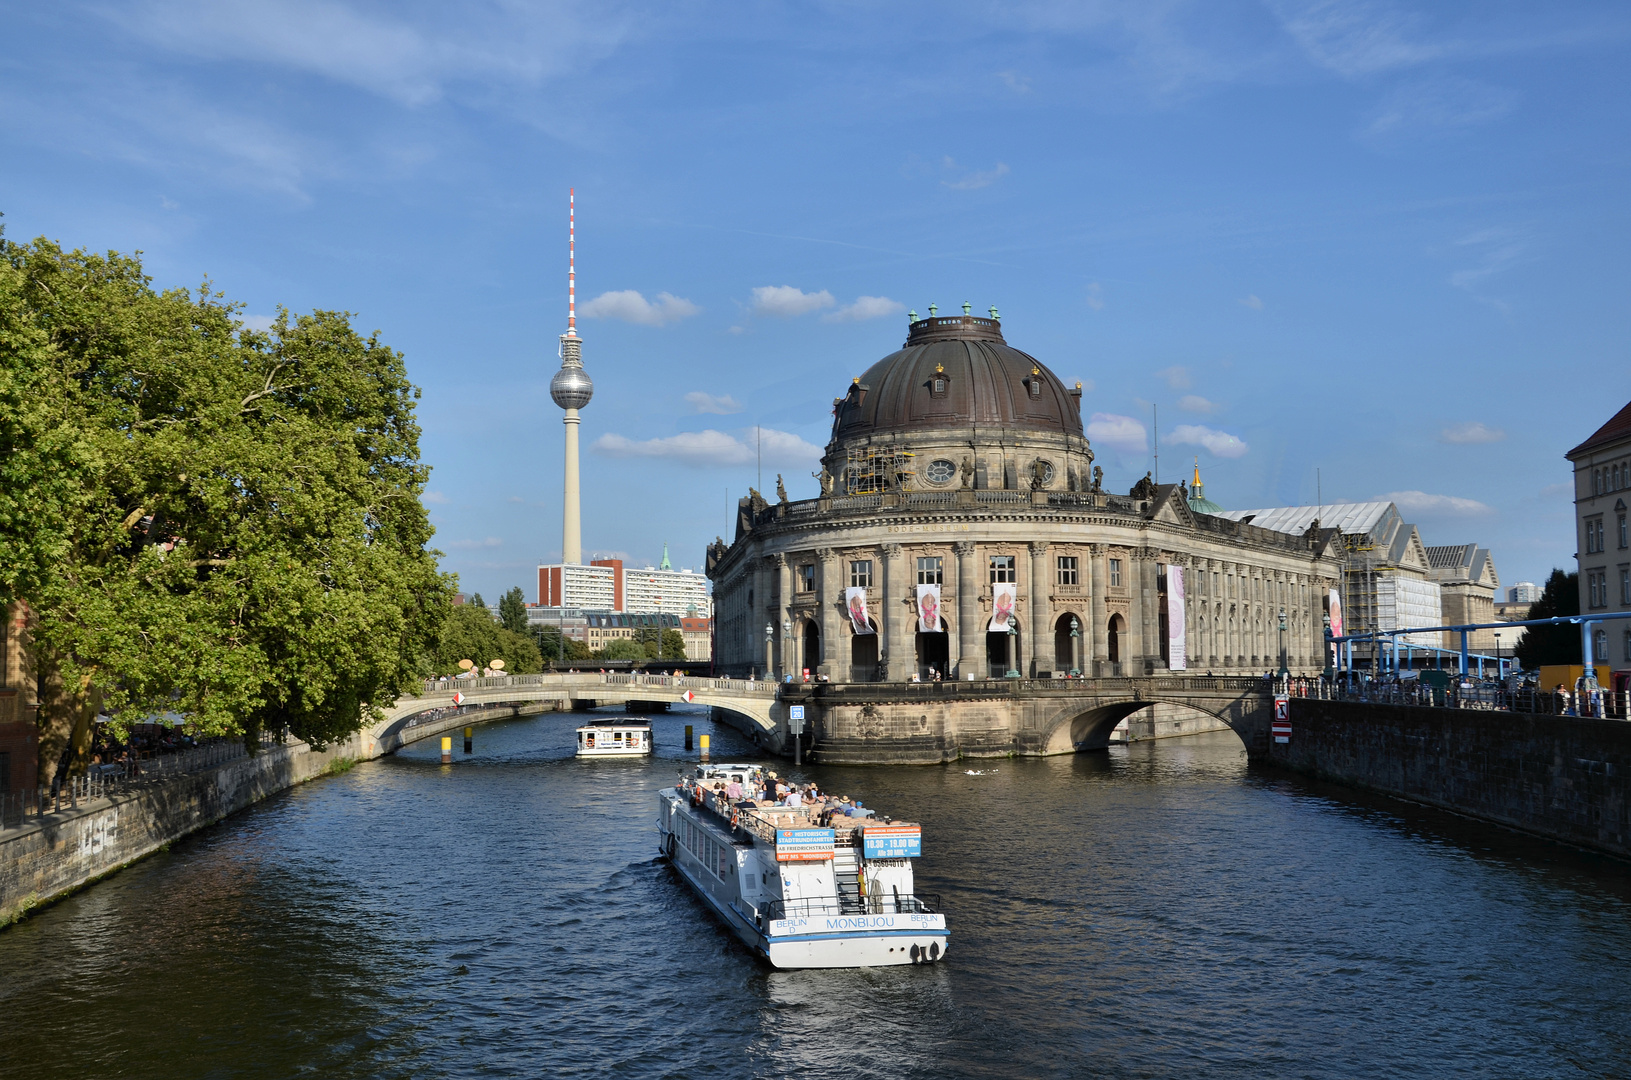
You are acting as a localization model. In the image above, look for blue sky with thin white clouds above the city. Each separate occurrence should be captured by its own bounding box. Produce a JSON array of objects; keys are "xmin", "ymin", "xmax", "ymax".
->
[{"xmin": 0, "ymin": 0, "xmax": 1631, "ymax": 600}]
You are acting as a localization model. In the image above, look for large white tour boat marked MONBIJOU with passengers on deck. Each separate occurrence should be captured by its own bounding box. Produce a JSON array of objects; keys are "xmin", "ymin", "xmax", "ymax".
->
[{"xmin": 657, "ymin": 765, "xmax": 948, "ymax": 967}]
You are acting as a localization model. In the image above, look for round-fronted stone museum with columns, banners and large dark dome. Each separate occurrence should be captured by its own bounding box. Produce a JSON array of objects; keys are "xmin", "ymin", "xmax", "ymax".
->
[{"xmin": 708, "ymin": 305, "xmax": 1342, "ymax": 682}]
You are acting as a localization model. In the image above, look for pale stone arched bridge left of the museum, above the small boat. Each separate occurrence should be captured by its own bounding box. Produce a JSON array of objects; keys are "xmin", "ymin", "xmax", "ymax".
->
[{"xmin": 359, "ymin": 672, "xmax": 786, "ymax": 757}]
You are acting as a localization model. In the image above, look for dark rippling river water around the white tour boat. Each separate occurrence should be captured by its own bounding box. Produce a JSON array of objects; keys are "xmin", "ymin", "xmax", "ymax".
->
[{"xmin": 0, "ymin": 711, "xmax": 1631, "ymax": 1080}]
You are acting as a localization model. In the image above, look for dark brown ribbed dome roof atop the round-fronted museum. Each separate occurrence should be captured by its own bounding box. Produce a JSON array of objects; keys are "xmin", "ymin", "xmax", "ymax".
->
[{"xmin": 832, "ymin": 305, "xmax": 1081, "ymax": 440}]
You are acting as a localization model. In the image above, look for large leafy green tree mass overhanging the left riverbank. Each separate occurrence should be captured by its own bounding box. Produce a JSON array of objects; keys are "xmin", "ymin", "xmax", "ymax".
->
[{"xmin": 0, "ymin": 240, "xmax": 452, "ymax": 780}]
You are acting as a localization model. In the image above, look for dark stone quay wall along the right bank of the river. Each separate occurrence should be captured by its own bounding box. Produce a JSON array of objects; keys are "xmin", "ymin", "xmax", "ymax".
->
[{"xmin": 1261, "ymin": 698, "xmax": 1631, "ymax": 858}]
